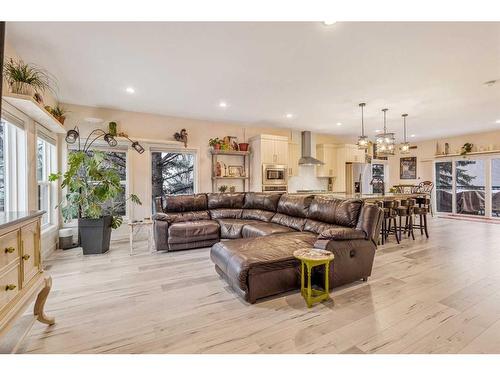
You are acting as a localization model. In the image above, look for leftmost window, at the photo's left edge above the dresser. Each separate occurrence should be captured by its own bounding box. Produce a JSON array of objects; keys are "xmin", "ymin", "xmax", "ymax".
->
[{"xmin": 0, "ymin": 116, "xmax": 27, "ymax": 212}]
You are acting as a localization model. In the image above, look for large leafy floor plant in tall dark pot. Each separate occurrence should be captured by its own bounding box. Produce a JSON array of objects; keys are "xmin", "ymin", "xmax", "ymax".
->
[{"xmin": 49, "ymin": 151, "xmax": 142, "ymax": 255}]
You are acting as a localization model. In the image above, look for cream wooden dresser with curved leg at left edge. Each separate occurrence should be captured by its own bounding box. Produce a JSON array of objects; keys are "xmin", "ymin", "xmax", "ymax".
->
[{"xmin": 0, "ymin": 211, "xmax": 54, "ymax": 350}]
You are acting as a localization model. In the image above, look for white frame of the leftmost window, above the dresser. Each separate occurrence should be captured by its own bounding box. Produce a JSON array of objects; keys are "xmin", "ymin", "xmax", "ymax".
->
[{"xmin": 1, "ymin": 111, "xmax": 28, "ymax": 211}]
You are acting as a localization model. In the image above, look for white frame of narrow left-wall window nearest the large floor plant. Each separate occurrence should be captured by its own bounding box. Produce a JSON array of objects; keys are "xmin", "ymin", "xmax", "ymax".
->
[{"xmin": 35, "ymin": 135, "xmax": 57, "ymax": 230}]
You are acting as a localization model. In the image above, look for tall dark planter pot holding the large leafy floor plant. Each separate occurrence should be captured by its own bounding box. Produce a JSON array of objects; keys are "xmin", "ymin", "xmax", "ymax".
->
[{"xmin": 78, "ymin": 216, "xmax": 112, "ymax": 255}]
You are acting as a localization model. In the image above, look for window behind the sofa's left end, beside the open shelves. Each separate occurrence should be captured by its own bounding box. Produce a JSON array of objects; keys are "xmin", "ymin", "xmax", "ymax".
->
[{"xmin": 151, "ymin": 152, "xmax": 195, "ymax": 206}]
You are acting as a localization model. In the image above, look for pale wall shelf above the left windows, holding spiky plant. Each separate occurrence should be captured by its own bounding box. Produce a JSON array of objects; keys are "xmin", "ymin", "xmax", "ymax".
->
[{"xmin": 2, "ymin": 94, "xmax": 66, "ymax": 134}]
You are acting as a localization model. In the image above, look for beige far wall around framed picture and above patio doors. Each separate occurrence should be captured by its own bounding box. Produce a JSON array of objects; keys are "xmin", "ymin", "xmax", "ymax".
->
[{"xmin": 389, "ymin": 130, "xmax": 500, "ymax": 186}]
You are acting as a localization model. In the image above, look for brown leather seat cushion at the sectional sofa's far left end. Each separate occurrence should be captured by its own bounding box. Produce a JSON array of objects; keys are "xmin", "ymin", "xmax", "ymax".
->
[{"xmin": 168, "ymin": 220, "xmax": 220, "ymax": 244}]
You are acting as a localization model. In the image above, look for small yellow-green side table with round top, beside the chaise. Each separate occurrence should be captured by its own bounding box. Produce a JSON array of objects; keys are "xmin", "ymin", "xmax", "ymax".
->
[{"xmin": 293, "ymin": 248, "xmax": 334, "ymax": 307}]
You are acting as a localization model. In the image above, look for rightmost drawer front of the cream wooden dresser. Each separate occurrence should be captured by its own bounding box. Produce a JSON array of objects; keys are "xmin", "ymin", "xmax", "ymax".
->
[{"xmin": 21, "ymin": 221, "xmax": 40, "ymax": 285}]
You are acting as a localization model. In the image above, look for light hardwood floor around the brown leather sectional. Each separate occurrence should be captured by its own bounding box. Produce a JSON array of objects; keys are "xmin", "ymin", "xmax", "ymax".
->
[{"xmin": 12, "ymin": 218, "xmax": 500, "ymax": 354}]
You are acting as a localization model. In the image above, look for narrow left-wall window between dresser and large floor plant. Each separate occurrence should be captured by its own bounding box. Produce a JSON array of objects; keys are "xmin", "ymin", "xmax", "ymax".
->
[{"xmin": 36, "ymin": 138, "xmax": 57, "ymax": 228}]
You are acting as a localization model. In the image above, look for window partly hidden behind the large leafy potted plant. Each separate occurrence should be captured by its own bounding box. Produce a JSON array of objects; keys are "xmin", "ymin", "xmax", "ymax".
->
[{"xmin": 69, "ymin": 148, "xmax": 127, "ymax": 219}]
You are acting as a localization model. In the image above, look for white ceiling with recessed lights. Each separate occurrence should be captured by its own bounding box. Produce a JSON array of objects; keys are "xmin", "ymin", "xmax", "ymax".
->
[{"xmin": 3, "ymin": 22, "xmax": 500, "ymax": 140}]
